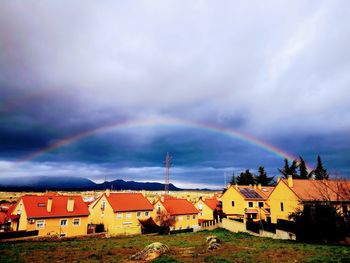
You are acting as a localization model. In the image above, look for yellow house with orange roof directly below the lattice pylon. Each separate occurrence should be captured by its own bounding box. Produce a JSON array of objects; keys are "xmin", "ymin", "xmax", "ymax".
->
[{"xmin": 153, "ymin": 195, "xmax": 198, "ymax": 231}]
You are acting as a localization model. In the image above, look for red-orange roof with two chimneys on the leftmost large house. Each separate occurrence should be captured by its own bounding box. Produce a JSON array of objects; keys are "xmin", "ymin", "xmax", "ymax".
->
[{"xmin": 21, "ymin": 195, "xmax": 89, "ymax": 218}]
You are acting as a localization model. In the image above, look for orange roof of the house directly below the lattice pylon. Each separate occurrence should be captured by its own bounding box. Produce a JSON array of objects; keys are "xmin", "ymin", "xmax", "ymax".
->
[{"xmin": 160, "ymin": 196, "xmax": 198, "ymax": 215}]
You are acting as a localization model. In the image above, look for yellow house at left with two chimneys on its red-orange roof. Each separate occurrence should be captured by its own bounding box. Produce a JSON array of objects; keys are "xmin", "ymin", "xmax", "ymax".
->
[{"xmin": 11, "ymin": 194, "xmax": 89, "ymax": 236}]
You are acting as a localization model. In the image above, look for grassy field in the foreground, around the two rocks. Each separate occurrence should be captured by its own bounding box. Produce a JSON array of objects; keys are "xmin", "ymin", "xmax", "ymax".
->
[{"xmin": 0, "ymin": 229, "xmax": 350, "ymax": 263}]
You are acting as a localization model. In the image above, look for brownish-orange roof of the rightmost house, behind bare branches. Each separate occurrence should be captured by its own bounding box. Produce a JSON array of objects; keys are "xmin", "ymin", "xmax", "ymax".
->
[{"xmin": 281, "ymin": 179, "xmax": 350, "ymax": 201}]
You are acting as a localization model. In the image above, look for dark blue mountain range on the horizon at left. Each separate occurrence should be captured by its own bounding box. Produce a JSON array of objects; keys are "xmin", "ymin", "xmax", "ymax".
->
[{"xmin": 0, "ymin": 176, "xmax": 182, "ymax": 191}]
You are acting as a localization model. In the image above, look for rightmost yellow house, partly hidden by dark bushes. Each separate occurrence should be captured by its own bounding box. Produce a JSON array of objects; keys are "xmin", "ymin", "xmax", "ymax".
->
[{"xmin": 269, "ymin": 176, "xmax": 350, "ymax": 223}]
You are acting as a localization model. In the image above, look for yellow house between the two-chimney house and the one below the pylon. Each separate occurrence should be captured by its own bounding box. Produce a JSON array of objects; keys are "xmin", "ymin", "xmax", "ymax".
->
[{"xmin": 89, "ymin": 190, "xmax": 153, "ymax": 235}]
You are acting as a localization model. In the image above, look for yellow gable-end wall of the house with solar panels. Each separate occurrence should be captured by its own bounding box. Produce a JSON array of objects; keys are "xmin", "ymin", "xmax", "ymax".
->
[{"xmin": 221, "ymin": 186, "xmax": 248, "ymax": 217}]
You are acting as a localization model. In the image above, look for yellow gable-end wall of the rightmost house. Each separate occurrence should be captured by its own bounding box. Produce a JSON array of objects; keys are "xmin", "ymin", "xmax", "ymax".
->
[{"xmin": 269, "ymin": 181, "xmax": 301, "ymax": 223}]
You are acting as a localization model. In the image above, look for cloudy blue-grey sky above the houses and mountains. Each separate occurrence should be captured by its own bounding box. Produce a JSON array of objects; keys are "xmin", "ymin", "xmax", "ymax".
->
[{"xmin": 0, "ymin": 0, "xmax": 350, "ymax": 188}]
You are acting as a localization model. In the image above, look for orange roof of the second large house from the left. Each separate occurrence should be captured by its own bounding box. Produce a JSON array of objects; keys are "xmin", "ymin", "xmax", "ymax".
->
[{"xmin": 104, "ymin": 193, "xmax": 153, "ymax": 212}]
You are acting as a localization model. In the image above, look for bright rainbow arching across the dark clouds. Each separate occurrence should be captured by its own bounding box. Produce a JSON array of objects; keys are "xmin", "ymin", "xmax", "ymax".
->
[{"xmin": 17, "ymin": 118, "xmax": 304, "ymax": 169}]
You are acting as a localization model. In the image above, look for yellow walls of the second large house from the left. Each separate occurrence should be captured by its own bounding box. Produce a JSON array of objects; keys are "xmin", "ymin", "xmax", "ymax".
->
[{"xmin": 89, "ymin": 196, "xmax": 152, "ymax": 235}]
